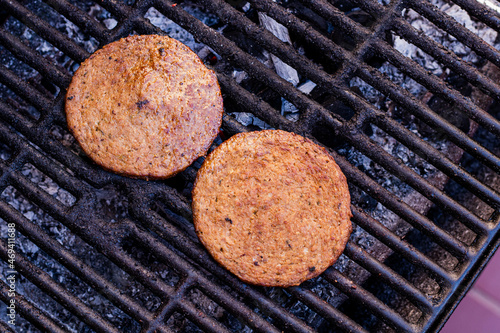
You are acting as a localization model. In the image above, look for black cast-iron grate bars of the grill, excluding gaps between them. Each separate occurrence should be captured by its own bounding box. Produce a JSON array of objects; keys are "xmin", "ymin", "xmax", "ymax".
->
[{"xmin": 0, "ymin": 0, "xmax": 500, "ymax": 332}]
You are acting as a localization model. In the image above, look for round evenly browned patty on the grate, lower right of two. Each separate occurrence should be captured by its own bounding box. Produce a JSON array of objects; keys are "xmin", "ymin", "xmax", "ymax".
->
[{"xmin": 193, "ymin": 130, "xmax": 352, "ymax": 287}]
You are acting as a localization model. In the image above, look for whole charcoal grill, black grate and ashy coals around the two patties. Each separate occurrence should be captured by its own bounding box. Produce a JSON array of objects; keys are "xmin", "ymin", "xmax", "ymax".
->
[{"xmin": 0, "ymin": 0, "xmax": 500, "ymax": 332}]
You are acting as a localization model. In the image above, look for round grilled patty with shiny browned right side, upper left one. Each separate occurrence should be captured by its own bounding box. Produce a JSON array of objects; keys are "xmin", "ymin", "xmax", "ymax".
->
[{"xmin": 66, "ymin": 35, "xmax": 223, "ymax": 178}]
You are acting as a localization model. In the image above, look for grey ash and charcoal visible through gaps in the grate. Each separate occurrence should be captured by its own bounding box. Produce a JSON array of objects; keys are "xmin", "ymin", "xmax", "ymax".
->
[{"xmin": 0, "ymin": 1, "xmax": 499, "ymax": 332}]
